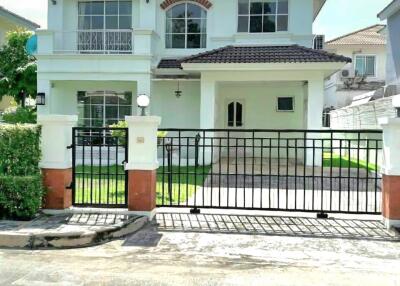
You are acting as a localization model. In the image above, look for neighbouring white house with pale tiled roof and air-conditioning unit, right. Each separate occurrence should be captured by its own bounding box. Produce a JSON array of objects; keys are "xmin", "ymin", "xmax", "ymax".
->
[{"xmin": 325, "ymin": 25, "xmax": 386, "ymax": 108}]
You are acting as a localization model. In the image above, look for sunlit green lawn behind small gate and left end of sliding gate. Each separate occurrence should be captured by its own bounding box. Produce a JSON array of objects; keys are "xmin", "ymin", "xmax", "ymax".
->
[{"xmin": 75, "ymin": 165, "xmax": 211, "ymax": 205}]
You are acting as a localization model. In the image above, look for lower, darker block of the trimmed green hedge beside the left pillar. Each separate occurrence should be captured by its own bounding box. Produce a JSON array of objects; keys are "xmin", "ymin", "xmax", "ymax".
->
[{"xmin": 0, "ymin": 175, "xmax": 44, "ymax": 220}]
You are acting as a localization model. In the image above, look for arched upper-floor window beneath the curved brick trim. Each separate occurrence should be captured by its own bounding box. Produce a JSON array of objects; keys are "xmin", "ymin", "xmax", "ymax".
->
[{"xmin": 165, "ymin": 3, "xmax": 207, "ymax": 49}]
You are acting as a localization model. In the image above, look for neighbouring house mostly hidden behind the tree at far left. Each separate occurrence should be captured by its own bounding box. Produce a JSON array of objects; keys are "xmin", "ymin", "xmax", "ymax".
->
[{"xmin": 0, "ymin": 6, "xmax": 40, "ymax": 112}]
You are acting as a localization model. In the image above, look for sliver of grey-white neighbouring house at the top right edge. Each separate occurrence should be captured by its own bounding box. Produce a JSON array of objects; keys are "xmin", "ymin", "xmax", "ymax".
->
[{"xmin": 378, "ymin": 0, "xmax": 400, "ymax": 85}]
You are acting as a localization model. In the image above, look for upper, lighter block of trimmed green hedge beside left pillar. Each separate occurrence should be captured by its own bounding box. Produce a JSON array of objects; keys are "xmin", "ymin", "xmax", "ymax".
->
[{"xmin": 0, "ymin": 125, "xmax": 41, "ymax": 176}]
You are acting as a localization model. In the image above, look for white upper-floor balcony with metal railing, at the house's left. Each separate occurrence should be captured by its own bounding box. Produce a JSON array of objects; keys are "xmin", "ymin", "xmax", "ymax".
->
[{"xmin": 36, "ymin": 29, "xmax": 159, "ymax": 76}]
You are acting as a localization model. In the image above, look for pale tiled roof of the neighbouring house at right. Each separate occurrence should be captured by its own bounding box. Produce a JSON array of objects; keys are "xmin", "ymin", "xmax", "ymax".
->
[{"xmin": 326, "ymin": 25, "xmax": 386, "ymax": 45}]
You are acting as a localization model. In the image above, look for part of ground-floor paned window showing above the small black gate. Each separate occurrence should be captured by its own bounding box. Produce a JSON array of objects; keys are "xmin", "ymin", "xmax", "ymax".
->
[{"xmin": 78, "ymin": 91, "xmax": 132, "ymax": 127}]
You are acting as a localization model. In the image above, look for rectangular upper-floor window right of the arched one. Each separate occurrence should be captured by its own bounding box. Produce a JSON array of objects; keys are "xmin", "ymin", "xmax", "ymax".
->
[{"xmin": 238, "ymin": 0, "xmax": 289, "ymax": 33}]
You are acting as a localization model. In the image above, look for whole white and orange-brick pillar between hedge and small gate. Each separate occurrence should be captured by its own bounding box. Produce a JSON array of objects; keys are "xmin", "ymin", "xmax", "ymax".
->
[{"xmin": 38, "ymin": 115, "xmax": 78, "ymax": 209}]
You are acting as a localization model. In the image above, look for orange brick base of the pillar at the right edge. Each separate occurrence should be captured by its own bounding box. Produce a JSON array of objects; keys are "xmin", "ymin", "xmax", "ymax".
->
[{"xmin": 382, "ymin": 175, "xmax": 400, "ymax": 226}]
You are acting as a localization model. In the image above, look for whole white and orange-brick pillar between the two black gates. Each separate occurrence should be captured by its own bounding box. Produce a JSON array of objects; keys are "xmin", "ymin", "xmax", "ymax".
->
[{"xmin": 125, "ymin": 116, "xmax": 161, "ymax": 219}]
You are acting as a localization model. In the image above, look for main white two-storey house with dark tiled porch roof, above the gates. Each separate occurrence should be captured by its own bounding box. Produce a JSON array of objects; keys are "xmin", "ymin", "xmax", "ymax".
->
[{"xmin": 37, "ymin": 0, "xmax": 351, "ymax": 129}]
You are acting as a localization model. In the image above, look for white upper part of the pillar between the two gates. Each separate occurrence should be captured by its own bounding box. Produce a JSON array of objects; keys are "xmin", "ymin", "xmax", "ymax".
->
[{"xmin": 125, "ymin": 116, "xmax": 161, "ymax": 170}]
